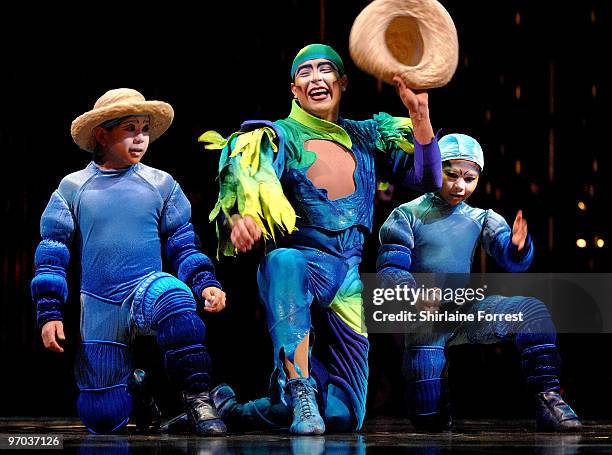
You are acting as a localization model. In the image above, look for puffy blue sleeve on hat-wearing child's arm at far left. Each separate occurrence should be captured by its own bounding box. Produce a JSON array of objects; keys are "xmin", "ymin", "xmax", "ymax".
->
[{"xmin": 30, "ymin": 191, "xmax": 75, "ymax": 328}]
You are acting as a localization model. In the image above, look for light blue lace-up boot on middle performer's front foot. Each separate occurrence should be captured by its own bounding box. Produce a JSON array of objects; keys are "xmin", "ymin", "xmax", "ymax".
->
[{"xmin": 287, "ymin": 378, "xmax": 325, "ymax": 435}]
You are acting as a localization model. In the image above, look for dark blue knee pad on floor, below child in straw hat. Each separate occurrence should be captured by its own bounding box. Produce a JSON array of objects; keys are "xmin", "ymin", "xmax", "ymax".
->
[{"xmin": 77, "ymin": 386, "xmax": 132, "ymax": 434}]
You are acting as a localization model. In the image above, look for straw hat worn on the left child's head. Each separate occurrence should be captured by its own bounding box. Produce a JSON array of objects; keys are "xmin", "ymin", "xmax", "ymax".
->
[{"xmin": 70, "ymin": 88, "xmax": 174, "ymax": 152}]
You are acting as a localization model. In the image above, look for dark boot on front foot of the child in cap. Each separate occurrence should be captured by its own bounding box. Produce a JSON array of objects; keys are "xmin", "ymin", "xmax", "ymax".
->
[{"xmin": 536, "ymin": 390, "xmax": 582, "ymax": 431}]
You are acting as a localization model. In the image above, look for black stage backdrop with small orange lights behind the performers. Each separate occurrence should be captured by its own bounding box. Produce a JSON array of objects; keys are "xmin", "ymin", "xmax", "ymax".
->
[{"xmin": 0, "ymin": 0, "xmax": 612, "ymax": 424}]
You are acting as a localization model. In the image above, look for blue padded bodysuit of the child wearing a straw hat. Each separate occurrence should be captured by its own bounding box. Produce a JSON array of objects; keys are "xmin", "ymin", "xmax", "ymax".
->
[{"xmin": 31, "ymin": 162, "xmax": 220, "ymax": 432}]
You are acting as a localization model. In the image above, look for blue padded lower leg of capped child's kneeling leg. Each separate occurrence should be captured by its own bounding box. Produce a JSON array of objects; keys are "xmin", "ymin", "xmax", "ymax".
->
[{"xmin": 402, "ymin": 346, "xmax": 446, "ymax": 416}]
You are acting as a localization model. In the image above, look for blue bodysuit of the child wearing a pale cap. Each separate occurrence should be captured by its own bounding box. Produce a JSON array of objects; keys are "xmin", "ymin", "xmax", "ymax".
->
[{"xmin": 377, "ymin": 193, "xmax": 559, "ymax": 426}]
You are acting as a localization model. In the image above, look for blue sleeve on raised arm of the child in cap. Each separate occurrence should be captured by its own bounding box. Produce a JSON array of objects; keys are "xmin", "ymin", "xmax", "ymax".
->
[{"xmin": 482, "ymin": 210, "xmax": 533, "ymax": 272}]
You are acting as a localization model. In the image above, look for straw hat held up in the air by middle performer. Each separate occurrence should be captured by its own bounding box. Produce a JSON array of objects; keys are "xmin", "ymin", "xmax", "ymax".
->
[{"xmin": 349, "ymin": 0, "xmax": 459, "ymax": 89}]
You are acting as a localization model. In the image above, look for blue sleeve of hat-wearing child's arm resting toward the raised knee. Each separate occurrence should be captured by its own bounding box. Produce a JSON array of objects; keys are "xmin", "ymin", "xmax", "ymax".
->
[{"xmin": 161, "ymin": 183, "xmax": 221, "ymax": 299}]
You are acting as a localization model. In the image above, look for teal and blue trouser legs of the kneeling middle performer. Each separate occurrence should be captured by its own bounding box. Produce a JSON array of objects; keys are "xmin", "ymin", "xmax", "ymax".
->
[{"xmin": 212, "ymin": 248, "xmax": 369, "ymax": 431}]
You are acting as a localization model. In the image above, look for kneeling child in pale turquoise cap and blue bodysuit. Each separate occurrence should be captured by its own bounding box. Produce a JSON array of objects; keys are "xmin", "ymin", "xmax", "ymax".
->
[{"xmin": 377, "ymin": 134, "xmax": 581, "ymax": 431}]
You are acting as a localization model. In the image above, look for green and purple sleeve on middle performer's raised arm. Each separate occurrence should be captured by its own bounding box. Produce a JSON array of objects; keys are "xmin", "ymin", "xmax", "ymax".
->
[{"xmin": 374, "ymin": 112, "xmax": 442, "ymax": 193}]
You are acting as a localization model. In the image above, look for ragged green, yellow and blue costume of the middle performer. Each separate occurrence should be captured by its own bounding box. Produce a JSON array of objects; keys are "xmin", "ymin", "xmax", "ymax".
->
[{"xmin": 200, "ymin": 101, "xmax": 441, "ymax": 430}]
